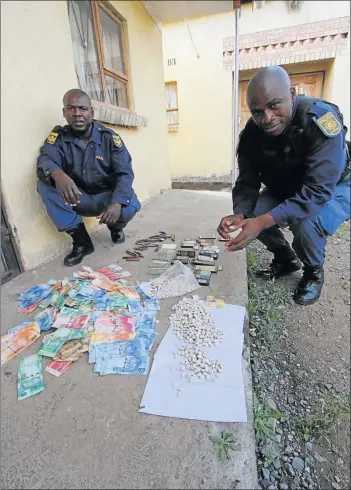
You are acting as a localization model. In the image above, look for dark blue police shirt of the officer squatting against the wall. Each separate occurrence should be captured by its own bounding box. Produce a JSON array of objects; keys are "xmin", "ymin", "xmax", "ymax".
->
[{"xmin": 37, "ymin": 122, "xmax": 134, "ymax": 206}]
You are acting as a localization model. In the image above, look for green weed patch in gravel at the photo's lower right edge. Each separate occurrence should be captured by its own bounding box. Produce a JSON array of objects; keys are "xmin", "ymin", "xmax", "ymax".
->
[{"xmin": 297, "ymin": 392, "xmax": 350, "ymax": 445}]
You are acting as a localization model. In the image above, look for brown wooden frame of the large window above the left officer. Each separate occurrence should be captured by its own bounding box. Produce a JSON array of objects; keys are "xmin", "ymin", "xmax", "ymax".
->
[{"xmin": 90, "ymin": 0, "xmax": 131, "ymax": 111}]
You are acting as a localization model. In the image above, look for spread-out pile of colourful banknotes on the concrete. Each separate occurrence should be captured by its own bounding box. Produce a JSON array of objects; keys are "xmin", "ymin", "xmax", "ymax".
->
[{"xmin": 1, "ymin": 264, "xmax": 160, "ymax": 400}]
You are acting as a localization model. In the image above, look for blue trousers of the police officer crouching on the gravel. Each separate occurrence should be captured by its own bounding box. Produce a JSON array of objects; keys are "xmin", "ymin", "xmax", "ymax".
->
[{"xmin": 254, "ymin": 181, "xmax": 350, "ymax": 266}]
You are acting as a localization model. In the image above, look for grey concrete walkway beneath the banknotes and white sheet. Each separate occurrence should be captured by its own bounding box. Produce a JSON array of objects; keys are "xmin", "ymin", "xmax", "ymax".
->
[{"xmin": 1, "ymin": 190, "xmax": 257, "ymax": 489}]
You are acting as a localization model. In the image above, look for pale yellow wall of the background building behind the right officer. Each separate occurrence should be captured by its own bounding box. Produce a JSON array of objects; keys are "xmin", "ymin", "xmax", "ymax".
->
[{"xmin": 163, "ymin": 1, "xmax": 350, "ymax": 177}]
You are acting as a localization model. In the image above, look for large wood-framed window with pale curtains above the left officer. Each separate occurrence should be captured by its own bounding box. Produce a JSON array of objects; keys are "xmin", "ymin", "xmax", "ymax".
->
[{"xmin": 68, "ymin": 0, "xmax": 130, "ymax": 109}]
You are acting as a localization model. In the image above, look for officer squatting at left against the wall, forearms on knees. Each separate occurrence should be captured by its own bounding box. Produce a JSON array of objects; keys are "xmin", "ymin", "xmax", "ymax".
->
[{"xmin": 37, "ymin": 89, "xmax": 141, "ymax": 266}]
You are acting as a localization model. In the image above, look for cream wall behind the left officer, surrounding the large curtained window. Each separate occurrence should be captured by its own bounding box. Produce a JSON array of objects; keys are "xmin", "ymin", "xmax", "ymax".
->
[{"xmin": 1, "ymin": 1, "xmax": 170, "ymax": 269}]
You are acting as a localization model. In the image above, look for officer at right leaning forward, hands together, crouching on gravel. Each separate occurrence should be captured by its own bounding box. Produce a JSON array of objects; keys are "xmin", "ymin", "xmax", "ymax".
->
[{"xmin": 218, "ymin": 67, "xmax": 350, "ymax": 305}]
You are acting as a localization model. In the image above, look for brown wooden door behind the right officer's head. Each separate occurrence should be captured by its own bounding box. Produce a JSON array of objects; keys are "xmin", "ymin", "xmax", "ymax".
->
[{"xmin": 239, "ymin": 72, "xmax": 324, "ymax": 132}]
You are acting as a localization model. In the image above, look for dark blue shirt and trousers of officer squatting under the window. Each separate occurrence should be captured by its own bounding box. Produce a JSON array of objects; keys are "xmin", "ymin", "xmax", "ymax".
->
[{"xmin": 37, "ymin": 122, "xmax": 141, "ymax": 231}]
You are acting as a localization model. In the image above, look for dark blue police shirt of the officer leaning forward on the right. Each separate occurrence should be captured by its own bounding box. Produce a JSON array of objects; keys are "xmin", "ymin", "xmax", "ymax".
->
[{"xmin": 232, "ymin": 96, "xmax": 347, "ymax": 227}]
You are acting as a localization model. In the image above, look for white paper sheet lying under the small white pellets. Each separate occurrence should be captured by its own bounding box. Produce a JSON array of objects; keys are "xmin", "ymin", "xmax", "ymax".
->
[{"xmin": 139, "ymin": 305, "xmax": 247, "ymax": 422}]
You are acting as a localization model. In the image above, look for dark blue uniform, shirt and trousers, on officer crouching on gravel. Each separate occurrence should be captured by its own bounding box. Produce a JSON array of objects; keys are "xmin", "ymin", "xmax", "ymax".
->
[{"xmin": 233, "ymin": 96, "xmax": 350, "ymax": 267}]
